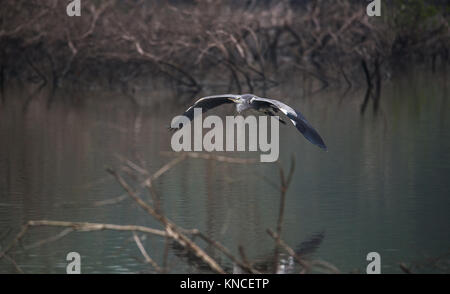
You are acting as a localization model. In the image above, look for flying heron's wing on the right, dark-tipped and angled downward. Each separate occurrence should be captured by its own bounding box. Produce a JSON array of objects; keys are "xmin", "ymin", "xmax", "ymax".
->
[{"xmin": 251, "ymin": 97, "xmax": 327, "ymax": 150}]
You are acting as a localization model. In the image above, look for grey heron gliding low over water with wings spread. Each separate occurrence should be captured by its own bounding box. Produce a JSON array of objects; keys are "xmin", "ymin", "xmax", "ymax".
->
[{"xmin": 171, "ymin": 94, "xmax": 327, "ymax": 150}]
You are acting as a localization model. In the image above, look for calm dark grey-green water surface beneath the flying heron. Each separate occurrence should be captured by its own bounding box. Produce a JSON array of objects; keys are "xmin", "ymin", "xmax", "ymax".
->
[{"xmin": 0, "ymin": 72, "xmax": 450, "ymax": 273}]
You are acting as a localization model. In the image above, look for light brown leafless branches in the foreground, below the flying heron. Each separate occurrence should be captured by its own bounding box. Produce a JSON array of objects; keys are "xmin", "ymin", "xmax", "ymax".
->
[{"xmin": 0, "ymin": 152, "xmax": 338, "ymax": 274}]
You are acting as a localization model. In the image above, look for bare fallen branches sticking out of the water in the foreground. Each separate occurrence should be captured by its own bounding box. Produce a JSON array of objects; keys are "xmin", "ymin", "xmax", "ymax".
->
[{"xmin": 0, "ymin": 153, "xmax": 339, "ymax": 274}]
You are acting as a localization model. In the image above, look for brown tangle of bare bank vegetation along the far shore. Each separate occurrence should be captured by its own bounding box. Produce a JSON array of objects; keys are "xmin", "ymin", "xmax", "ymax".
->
[{"xmin": 0, "ymin": 0, "xmax": 450, "ymax": 99}]
